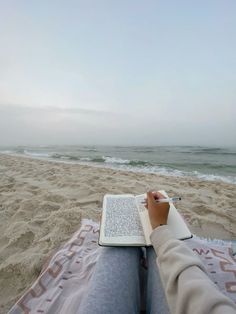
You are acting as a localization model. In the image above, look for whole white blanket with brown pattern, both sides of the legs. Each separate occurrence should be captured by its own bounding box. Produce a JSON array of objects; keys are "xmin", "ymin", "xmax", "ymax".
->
[{"xmin": 8, "ymin": 220, "xmax": 236, "ymax": 314}]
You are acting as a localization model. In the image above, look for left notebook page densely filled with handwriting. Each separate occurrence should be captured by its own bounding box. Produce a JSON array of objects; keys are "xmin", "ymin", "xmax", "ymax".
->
[{"xmin": 100, "ymin": 194, "xmax": 145, "ymax": 245}]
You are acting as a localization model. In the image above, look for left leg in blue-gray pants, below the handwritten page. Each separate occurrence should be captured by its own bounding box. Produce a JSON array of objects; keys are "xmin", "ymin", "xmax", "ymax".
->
[{"xmin": 79, "ymin": 247, "xmax": 141, "ymax": 314}]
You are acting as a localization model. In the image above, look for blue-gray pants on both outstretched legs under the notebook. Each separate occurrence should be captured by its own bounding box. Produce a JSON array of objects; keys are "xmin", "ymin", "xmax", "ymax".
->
[{"xmin": 79, "ymin": 247, "xmax": 169, "ymax": 314}]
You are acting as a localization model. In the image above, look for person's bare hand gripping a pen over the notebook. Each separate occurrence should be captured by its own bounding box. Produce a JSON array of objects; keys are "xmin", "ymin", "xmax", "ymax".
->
[{"xmin": 145, "ymin": 192, "xmax": 170, "ymax": 229}]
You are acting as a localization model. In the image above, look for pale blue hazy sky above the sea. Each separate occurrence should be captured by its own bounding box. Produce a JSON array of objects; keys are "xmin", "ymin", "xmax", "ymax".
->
[{"xmin": 0, "ymin": 0, "xmax": 236, "ymax": 146}]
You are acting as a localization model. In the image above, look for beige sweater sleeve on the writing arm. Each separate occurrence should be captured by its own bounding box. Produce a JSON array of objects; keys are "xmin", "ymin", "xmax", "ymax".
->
[{"xmin": 150, "ymin": 226, "xmax": 236, "ymax": 314}]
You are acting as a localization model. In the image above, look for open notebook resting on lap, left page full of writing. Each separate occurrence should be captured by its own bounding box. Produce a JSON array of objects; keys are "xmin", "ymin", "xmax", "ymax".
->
[{"xmin": 99, "ymin": 191, "xmax": 192, "ymax": 246}]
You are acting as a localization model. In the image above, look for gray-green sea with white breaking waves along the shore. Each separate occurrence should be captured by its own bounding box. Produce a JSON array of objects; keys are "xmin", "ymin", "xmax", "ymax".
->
[{"xmin": 0, "ymin": 145, "xmax": 236, "ymax": 184}]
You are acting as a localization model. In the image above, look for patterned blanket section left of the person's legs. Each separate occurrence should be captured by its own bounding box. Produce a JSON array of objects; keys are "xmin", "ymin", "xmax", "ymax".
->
[{"xmin": 9, "ymin": 220, "xmax": 100, "ymax": 314}]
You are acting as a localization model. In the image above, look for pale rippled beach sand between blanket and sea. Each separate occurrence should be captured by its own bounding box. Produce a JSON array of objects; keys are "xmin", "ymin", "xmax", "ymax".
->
[{"xmin": 0, "ymin": 155, "xmax": 236, "ymax": 313}]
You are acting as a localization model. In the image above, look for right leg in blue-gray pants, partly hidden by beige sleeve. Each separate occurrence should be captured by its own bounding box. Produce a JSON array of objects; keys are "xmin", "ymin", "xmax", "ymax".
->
[{"xmin": 146, "ymin": 247, "xmax": 170, "ymax": 314}]
